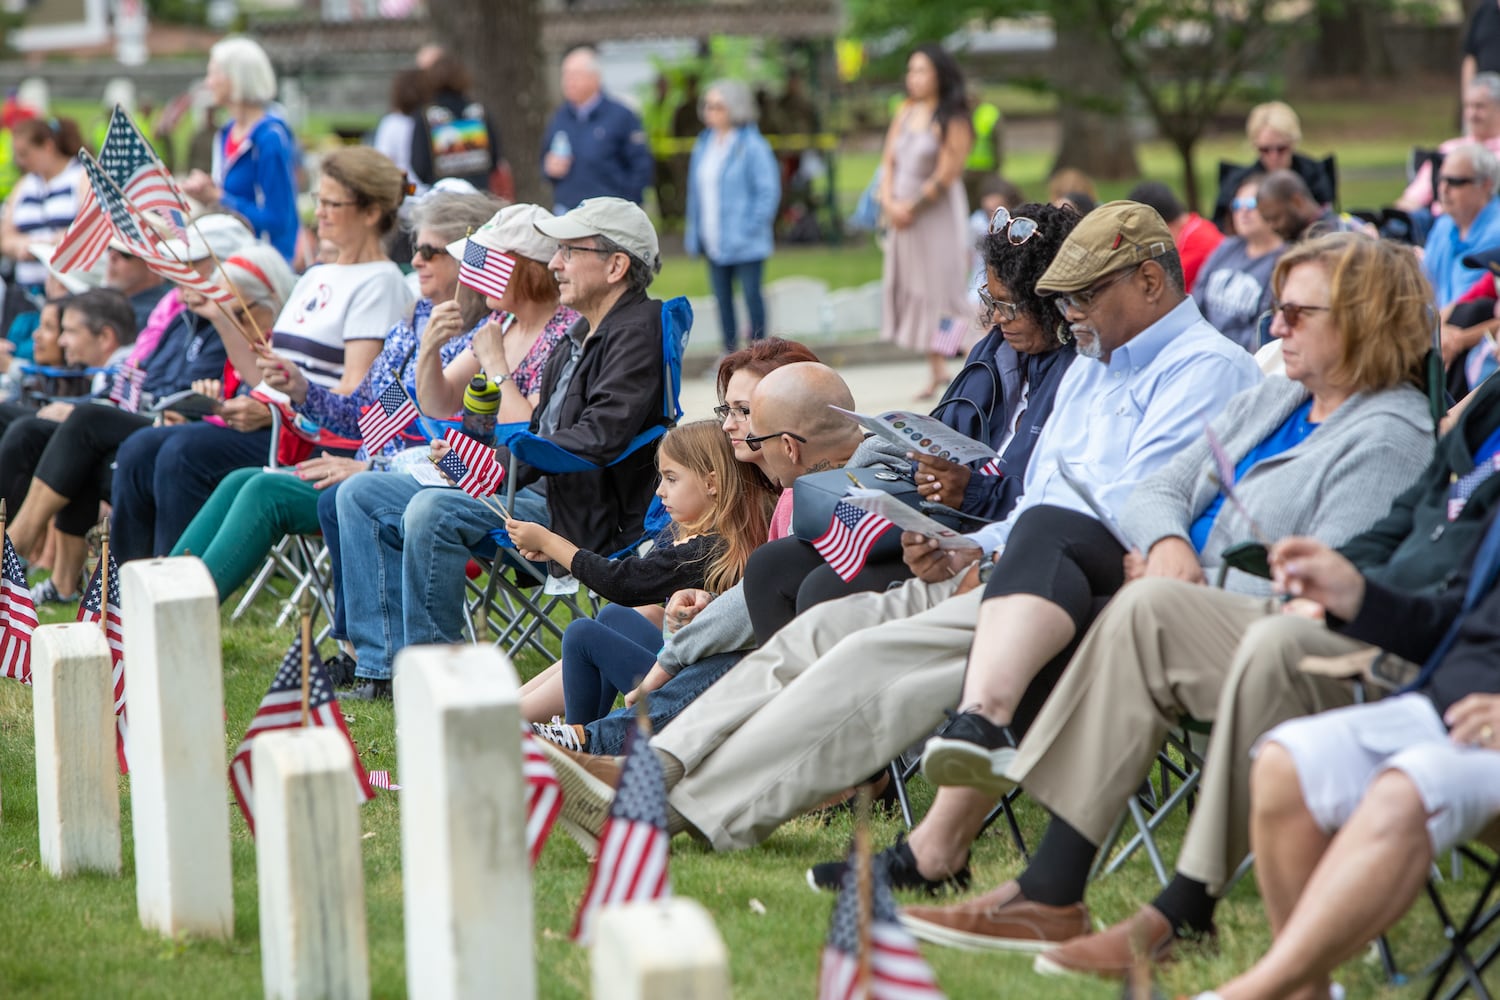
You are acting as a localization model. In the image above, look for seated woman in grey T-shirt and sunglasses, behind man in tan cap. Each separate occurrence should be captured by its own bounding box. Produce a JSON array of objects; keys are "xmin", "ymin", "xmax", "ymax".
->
[{"xmin": 1193, "ymin": 174, "xmax": 1287, "ymax": 354}]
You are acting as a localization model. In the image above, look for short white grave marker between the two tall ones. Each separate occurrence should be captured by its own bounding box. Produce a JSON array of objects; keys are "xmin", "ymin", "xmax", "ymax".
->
[{"xmin": 251, "ymin": 727, "xmax": 371, "ymax": 1000}]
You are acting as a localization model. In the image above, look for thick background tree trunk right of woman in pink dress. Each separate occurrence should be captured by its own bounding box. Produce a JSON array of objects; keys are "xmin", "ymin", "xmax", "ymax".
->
[{"xmin": 1052, "ymin": 13, "xmax": 1140, "ymax": 180}]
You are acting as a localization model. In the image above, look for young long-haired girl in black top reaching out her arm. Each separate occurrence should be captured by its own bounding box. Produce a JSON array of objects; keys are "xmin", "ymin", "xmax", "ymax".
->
[{"xmin": 506, "ymin": 420, "xmax": 770, "ymax": 748}]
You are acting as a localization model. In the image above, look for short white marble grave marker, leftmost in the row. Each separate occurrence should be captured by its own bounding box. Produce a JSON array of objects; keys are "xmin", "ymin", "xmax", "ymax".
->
[{"xmin": 32, "ymin": 624, "xmax": 120, "ymax": 877}]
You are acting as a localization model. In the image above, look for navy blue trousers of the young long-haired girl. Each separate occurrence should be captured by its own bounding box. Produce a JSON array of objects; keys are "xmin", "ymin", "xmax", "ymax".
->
[{"xmin": 563, "ymin": 604, "xmax": 662, "ymax": 723}]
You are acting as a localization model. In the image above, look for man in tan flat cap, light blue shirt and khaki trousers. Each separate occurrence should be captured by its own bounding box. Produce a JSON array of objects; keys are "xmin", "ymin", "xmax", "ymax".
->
[{"xmin": 548, "ymin": 202, "xmax": 1260, "ymax": 850}]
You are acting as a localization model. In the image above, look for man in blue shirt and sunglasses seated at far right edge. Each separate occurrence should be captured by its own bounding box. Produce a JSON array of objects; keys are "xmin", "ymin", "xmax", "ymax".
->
[{"xmin": 1422, "ymin": 142, "xmax": 1500, "ymax": 307}]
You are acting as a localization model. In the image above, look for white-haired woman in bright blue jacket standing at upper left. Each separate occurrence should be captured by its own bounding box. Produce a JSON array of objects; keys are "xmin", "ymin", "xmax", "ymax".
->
[{"xmin": 183, "ymin": 37, "xmax": 297, "ymax": 261}]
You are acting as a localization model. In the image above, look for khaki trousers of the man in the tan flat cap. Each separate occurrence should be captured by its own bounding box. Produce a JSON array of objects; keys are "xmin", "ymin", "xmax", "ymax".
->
[{"xmin": 663, "ymin": 574, "xmax": 984, "ymax": 850}]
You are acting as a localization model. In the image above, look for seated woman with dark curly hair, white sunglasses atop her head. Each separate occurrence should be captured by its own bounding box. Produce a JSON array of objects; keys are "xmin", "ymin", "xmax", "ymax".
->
[{"xmin": 746, "ymin": 204, "xmax": 1079, "ymax": 642}]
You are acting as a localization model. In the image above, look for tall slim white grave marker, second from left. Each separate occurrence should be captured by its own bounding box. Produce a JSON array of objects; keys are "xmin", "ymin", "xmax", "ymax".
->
[{"xmin": 120, "ymin": 556, "xmax": 234, "ymax": 937}]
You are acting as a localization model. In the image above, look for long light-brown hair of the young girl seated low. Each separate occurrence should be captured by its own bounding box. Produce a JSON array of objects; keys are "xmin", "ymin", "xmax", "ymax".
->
[{"xmin": 657, "ymin": 420, "xmax": 774, "ymax": 594}]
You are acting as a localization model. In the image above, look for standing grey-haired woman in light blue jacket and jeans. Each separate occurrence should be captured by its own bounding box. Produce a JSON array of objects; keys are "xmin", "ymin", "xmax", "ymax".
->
[{"xmin": 686, "ymin": 79, "xmax": 782, "ymax": 352}]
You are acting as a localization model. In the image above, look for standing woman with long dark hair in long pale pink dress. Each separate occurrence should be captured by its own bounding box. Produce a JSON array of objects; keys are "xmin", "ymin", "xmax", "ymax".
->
[{"xmin": 879, "ymin": 45, "xmax": 974, "ymax": 399}]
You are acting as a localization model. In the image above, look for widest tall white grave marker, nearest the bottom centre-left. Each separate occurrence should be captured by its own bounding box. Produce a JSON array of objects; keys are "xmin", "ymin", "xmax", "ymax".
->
[{"xmin": 396, "ymin": 646, "xmax": 537, "ymax": 1000}]
